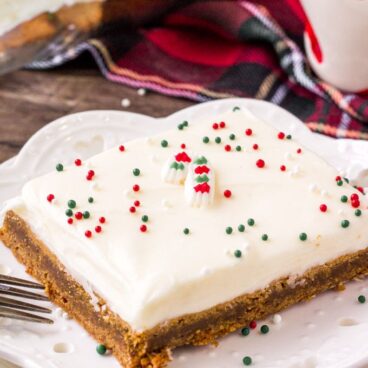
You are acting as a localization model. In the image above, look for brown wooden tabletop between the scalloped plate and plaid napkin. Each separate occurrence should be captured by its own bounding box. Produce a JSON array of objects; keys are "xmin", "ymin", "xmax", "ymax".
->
[{"xmin": 0, "ymin": 56, "xmax": 193, "ymax": 163}]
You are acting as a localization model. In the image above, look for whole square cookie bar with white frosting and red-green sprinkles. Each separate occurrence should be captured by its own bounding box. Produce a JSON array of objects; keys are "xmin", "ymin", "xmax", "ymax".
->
[{"xmin": 1, "ymin": 108, "xmax": 368, "ymax": 368}]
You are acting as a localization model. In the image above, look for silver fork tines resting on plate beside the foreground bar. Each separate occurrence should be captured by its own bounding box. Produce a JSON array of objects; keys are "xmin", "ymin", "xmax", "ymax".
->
[{"xmin": 0, "ymin": 274, "xmax": 54, "ymax": 324}]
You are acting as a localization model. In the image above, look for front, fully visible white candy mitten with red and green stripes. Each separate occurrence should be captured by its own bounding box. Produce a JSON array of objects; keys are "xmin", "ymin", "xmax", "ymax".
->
[{"xmin": 185, "ymin": 156, "xmax": 215, "ymax": 207}]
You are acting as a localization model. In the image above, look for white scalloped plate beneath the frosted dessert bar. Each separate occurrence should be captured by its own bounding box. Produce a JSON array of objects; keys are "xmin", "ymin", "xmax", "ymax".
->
[{"xmin": 0, "ymin": 99, "xmax": 368, "ymax": 368}]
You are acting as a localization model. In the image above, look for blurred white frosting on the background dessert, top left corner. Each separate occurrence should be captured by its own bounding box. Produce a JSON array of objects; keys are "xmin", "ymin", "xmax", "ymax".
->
[{"xmin": 0, "ymin": 0, "xmax": 93, "ymax": 36}]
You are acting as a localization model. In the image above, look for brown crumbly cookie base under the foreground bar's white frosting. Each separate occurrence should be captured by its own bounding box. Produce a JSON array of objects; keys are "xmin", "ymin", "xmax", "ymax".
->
[{"xmin": 0, "ymin": 211, "xmax": 368, "ymax": 368}]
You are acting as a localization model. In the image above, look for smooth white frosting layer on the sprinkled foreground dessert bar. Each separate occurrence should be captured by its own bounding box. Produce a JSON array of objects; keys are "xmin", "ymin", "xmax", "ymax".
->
[{"xmin": 6, "ymin": 106, "xmax": 368, "ymax": 331}]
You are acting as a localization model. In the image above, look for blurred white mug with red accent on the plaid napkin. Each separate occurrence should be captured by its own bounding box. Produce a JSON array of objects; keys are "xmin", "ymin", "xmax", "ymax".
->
[{"xmin": 301, "ymin": 0, "xmax": 368, "ymax": 92}]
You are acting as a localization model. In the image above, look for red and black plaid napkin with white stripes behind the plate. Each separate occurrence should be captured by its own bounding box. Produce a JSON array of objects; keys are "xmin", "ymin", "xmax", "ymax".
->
[{"xmin": 31, "ymin": 0, "xmax": 368, "ymax": 139}]
